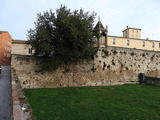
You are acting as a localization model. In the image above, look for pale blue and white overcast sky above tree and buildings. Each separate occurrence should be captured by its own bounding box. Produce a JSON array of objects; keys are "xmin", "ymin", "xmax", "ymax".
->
[{"xmin": 0, "ymin": 0, "xmax": 160, "ymax": 40}]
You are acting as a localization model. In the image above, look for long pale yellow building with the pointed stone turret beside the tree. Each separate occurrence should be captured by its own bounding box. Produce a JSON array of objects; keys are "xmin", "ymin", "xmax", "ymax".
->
[{"xmin": 94, "ymin": 21, "xmax": 160, "ymax": 51}]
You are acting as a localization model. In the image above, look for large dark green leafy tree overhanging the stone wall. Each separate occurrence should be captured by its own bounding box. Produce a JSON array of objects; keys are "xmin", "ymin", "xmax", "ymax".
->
[{"xmin": 28, "ymin": 6, "xmax": 95, "ymax": 70}]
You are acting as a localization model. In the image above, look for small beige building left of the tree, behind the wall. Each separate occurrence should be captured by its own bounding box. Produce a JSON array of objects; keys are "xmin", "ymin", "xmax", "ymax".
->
[{"xmin": 12, "ymin": 40, "xmax": 34, "ymax": 55}]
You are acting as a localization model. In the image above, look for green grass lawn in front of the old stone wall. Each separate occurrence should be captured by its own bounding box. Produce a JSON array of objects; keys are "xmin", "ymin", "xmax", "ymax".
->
[{"xmin": 25, "ymin": 84, "xmax": 160, "ymax": 120}]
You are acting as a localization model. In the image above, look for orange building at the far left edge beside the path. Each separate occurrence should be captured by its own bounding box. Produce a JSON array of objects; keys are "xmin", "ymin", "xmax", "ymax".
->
[{"xmin": 0, "ymin": 31, "xmax": 12, "ymax": 65}]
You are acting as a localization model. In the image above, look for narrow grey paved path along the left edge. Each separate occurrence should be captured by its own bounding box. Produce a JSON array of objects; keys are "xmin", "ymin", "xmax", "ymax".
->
[{"xmin": 0, "ymin": 66, "xmax": 11, "ymax": 120}]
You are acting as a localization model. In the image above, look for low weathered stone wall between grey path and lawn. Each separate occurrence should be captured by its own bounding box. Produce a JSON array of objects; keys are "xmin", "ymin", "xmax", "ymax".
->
[{"xmin": 12, "ymin": 69, "xmax": 32, "ymax": 120}]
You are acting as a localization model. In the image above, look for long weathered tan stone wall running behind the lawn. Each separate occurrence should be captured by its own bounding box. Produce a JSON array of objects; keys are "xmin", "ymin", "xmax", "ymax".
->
[{"xmin": 11, "ymin": 47, "xmax": 160, "ymax": 88}]
